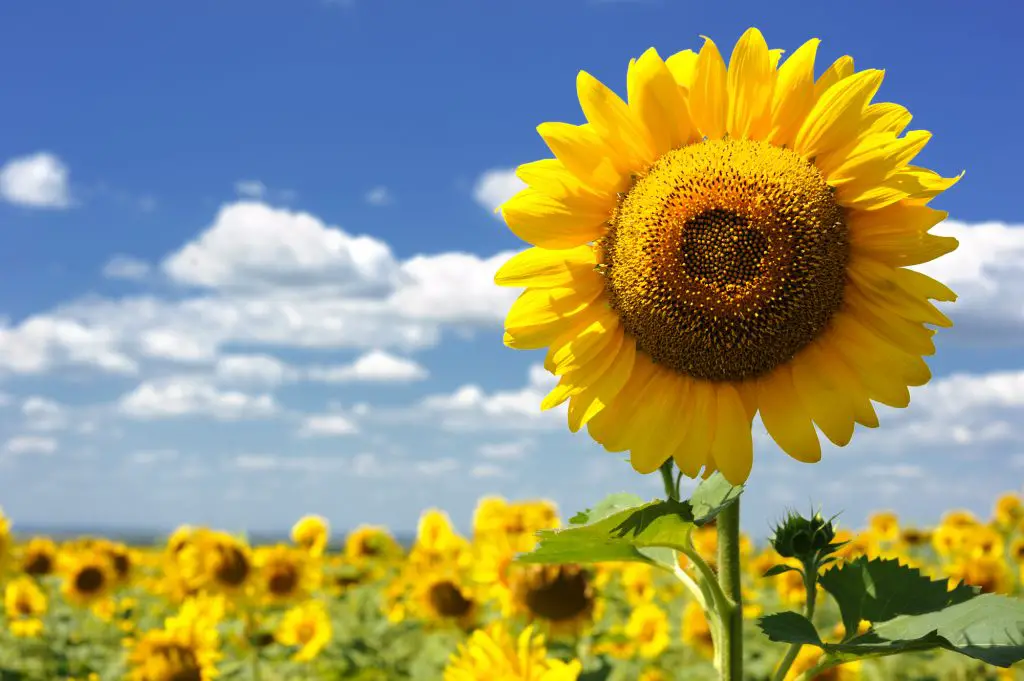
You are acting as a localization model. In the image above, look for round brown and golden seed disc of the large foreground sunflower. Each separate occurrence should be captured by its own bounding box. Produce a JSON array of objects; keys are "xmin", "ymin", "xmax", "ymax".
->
[{"xmin": 598, "ymin": 139, "xmax": 849, "ymax": 381}]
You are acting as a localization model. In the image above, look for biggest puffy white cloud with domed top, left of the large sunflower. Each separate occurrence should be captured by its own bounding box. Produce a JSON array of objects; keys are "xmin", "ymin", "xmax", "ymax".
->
[{"xmin": 163, "ymin": 202, "xmax": 397, "ymax": 292}]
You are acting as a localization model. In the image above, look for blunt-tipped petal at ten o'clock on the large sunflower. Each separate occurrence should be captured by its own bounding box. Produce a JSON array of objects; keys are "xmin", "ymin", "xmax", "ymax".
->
[{"xmin": 537, "ymin": 123, "xmax": 630, "ymax": 194}]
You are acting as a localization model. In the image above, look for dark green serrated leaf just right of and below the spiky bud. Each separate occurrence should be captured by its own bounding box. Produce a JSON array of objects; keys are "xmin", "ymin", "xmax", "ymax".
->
[{"xmin": 818, "ymin": 556, "xmax": 977, "ymax": 634}]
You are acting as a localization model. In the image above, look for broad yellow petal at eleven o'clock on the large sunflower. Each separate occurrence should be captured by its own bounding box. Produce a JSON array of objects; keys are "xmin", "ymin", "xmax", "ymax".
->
[{"xmin": 628, "ymin": 48, "xmax": 693, "ymax": 156}]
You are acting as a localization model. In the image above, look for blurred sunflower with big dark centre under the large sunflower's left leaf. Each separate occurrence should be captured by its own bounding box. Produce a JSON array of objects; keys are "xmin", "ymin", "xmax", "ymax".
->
[{"xmin": 509, "ymin": 564, "xmax": 599, "ymax": 634}]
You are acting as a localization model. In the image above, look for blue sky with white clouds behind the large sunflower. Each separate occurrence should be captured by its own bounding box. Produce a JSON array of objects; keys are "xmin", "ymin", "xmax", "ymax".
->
[{"xmin": 0, "ymin": 0, "xmax": 1024, "ymax": 534}]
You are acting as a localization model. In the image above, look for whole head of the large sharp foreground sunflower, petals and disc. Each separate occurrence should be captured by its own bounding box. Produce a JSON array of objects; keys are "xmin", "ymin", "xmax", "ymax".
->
[{"xmin": 496, "ymin": 29, "xmax": 958, "ymax": 483}]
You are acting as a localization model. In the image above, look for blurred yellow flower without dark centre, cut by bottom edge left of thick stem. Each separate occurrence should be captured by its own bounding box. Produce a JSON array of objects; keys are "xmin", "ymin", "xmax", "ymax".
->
[{"xmin": 443, "ymin": 622, "xmax": 582, "ymax": 681}]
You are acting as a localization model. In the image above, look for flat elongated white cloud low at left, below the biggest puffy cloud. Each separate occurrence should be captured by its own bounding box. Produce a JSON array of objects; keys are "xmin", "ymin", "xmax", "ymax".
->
[{"xmin": 118, "ymin": 377, "xmax": 278, "ymax": 421}]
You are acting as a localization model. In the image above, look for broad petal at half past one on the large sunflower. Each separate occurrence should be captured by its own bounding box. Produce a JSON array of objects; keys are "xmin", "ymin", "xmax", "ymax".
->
[{"xmin": 794, "ymin": 69, "xmax": 885, "ymax": 159}]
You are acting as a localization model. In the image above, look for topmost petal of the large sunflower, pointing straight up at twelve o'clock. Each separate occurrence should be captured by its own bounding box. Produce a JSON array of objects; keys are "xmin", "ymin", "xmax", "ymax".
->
[{"xmin": 726, "ymin": 28, "xmax": 774, "ymax": 139}]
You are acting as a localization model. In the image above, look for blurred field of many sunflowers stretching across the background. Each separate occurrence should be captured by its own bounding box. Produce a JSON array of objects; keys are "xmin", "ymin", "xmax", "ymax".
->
[{"xmin": 0, "ymin": 494, "xmax": 1024, "ymax": 681}]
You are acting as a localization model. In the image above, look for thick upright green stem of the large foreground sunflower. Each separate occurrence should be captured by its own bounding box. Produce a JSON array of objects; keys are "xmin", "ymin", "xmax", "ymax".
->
[{"xmin": 716, "ymin": 499, "xmax": 743, "ymax": 681}]
